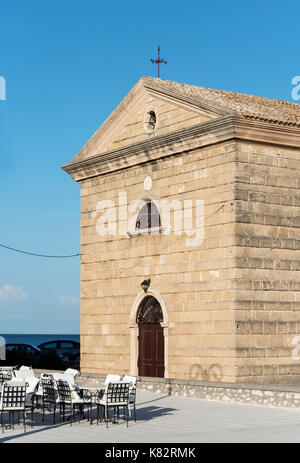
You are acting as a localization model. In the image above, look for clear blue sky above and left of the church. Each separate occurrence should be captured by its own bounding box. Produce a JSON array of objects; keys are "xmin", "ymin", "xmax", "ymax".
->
[{"xmin": 0, "ymin": 0, "xmax": 300, "ymax": 334}]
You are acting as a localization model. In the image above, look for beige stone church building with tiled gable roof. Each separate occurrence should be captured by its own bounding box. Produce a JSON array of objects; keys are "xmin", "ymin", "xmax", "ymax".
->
[{"xmin": 63, "ymin": 77, "xmax": 300, "ymax": 384}]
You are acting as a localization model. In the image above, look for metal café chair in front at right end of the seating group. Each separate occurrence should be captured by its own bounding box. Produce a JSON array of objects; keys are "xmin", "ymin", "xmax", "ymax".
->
[{"xmin": 97, "ymin": 382, "xmax": 130, "ymax": 427}]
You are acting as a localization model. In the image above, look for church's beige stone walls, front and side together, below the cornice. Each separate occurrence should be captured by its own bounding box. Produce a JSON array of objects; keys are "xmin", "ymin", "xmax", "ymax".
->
[{"xmin": 81, "ymin": 137, "xmax": 300, "ymax": 384}]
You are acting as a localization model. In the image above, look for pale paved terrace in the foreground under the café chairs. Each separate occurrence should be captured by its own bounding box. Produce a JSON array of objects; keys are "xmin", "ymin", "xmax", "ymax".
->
[{"xmin": 0, "ymin": 390, "xmax": 300, "ymax": 443}]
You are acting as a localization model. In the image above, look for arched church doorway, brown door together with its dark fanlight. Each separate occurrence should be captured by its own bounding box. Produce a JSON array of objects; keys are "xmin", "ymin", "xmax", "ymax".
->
[{"xmin": 136, "ymin": 296, "xmax": 165, "ymax": 378}]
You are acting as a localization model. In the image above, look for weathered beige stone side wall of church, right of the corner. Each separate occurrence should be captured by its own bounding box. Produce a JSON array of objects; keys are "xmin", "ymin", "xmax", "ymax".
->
[{"xmin": 236, "ymin": 143, "xmax": 300, "ymax": 384}]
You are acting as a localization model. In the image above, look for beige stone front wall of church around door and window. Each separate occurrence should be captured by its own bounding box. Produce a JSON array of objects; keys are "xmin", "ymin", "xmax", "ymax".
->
[{"xmin": 81, "ymin": 142, "xmax": 239, "ymax": 381}]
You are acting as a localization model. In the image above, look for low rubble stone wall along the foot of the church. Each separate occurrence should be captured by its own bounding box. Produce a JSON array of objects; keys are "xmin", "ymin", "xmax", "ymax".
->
[{"xmin": 79, "ymin": 373, "xmax": 300, "ymax": 408}]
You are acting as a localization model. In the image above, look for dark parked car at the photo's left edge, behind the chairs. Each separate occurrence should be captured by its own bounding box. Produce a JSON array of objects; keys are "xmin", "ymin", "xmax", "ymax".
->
[{"xmin": 0, "ymin": 343, "xmax": 66, "ymax": 368}]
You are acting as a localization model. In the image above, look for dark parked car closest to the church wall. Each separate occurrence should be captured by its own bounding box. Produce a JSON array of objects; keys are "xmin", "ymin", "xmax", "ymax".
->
[{"xmin": 38, "ymin": 339, "xmax": 80, "ymax": 368}]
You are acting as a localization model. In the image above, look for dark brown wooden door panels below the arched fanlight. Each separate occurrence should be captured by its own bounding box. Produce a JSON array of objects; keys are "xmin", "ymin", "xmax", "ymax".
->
[{"xmin": 138, "ymin": 324, "xmax": 165, "ymax": 378}]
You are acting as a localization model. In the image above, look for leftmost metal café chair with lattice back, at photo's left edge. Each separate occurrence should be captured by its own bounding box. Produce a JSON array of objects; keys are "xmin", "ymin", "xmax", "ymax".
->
[{"xmin": 0, "ymin": 381, "xmax": 26, "ymax": 433}]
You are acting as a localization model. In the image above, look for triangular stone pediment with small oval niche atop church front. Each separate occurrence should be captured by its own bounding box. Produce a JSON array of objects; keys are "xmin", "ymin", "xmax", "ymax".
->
[{"xmin": 73, "ymin": 78, "xmax": 231, "ymax": 162}]
